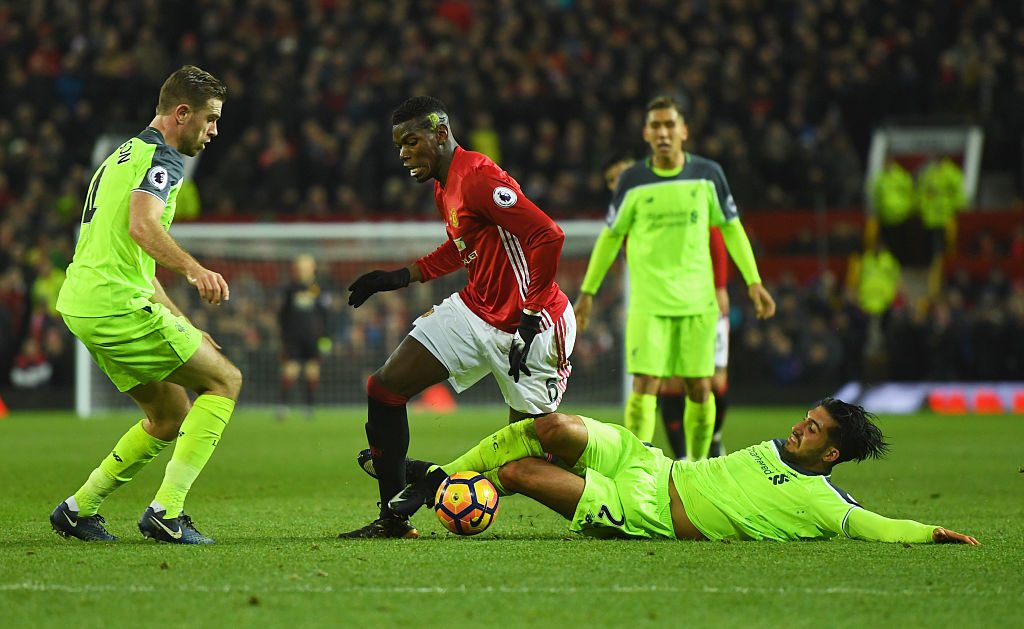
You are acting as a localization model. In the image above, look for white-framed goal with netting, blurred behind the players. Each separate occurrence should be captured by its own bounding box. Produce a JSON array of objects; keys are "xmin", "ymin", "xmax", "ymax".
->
[{"xmin": 76, "ymin": 221, "xmax": 626, "ymax": 417}]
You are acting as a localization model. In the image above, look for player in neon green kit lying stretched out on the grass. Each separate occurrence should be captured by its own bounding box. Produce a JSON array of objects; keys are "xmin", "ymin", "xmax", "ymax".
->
[{"xmin": 382, "ymin": 397, "xmax": 978, "ymax": 545}]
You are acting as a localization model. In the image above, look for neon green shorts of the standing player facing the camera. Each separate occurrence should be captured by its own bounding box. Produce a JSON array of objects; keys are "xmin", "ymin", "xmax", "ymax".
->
[{"xmin": 626, "ymin": 310, "xmax": 718, "ymax": 378}]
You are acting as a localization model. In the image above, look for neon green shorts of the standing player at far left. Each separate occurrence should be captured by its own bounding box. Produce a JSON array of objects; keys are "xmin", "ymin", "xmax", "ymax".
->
[{"xmin": 61, "ymin": 303, "xmax": 203, "ymax": 391}]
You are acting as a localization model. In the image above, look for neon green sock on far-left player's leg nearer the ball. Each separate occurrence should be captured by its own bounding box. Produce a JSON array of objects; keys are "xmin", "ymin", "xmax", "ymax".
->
[{"xmin": 154, "ymin": 393, "xmax": 234, "ymax": 518}]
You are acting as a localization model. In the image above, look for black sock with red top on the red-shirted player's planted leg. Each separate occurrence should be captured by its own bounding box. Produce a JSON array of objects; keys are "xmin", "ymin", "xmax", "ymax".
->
[{"xmin": 367, "ymin": 376, "xmax": 409, "ymax": 517}]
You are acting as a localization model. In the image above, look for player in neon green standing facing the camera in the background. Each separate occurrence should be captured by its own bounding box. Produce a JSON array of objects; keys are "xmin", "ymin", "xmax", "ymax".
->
[{"xmin": 574, "ymin": 96, "xmax": 775, "ymax": 460}]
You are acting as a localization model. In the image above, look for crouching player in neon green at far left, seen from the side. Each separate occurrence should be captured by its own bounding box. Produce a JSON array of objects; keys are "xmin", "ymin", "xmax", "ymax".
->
[{"xmin": 50, "ymin": 66, "xmax": 242, "ymax": 544}]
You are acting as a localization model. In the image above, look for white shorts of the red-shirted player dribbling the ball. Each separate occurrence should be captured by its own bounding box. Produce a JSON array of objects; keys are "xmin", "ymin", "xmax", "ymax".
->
[{"xmin": 409, "ymin": 293, "xmax": 575, "ymax": 415}]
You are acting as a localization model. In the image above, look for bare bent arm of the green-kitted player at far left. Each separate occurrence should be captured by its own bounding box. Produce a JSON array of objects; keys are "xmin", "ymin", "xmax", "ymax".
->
[{"xmin": 128, "ymin": 192, "xmax": 229, "ymax": 305}]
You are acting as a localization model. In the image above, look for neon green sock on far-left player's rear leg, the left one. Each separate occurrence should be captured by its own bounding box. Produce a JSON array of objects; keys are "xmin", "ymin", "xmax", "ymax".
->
[{"xmin": 74, "ymin": 420, "xmax": 170, "ymax": 517}]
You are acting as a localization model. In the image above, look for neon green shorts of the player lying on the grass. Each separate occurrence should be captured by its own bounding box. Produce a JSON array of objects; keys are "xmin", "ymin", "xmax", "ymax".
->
[{"xmin": 569, "ymin": 417, "xmax": 676, "ymax": 540}]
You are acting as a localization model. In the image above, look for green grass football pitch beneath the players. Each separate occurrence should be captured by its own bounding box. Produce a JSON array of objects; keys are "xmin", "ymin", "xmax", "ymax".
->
[{"xmin": 0, "ymin": 408, "xmax": 1024, "ymax": 628}]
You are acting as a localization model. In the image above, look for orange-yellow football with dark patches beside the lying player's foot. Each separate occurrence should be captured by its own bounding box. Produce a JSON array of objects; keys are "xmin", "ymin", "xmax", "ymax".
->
[{"xmin": 434, "ymin": 472, "xmax": 498, "ymax": 535}]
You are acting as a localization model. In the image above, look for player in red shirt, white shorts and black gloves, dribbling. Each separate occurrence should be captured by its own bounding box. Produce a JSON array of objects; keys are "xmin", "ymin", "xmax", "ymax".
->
[{"xmin": 339, "ymin": 96, "xmax": 575, "ymax": 538}]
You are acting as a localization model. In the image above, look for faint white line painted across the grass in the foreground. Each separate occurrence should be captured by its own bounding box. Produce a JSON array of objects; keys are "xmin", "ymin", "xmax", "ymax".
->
[{"xmin": 0, "ymin": 581, "xmax": 1011, "ymax": 597}]
